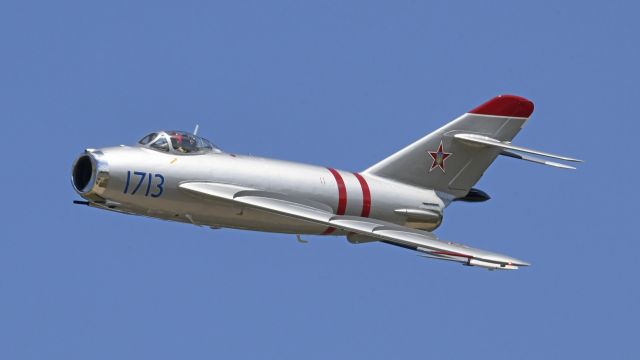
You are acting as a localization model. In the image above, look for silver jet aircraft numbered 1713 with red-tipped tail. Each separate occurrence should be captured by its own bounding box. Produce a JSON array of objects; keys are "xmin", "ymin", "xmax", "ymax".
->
[{"xmin": 71, "ymin": 95, "xmax": 581, "ymax": 270}]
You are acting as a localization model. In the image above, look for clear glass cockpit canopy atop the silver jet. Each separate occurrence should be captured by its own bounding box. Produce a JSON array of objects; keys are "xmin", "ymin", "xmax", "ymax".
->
[{"xmin": 138, "ymin": 130, "xmax": 222, "ymax": 155}]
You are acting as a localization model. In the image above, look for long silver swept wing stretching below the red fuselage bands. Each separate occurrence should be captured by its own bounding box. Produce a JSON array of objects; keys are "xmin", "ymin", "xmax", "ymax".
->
[{"xmin": 179, "ymin": 182, "xmax": 529, "ymax": 270}]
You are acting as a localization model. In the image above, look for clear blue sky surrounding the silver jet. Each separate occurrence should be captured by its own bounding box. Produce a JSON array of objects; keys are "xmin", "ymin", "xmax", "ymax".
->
[{"xmin": 0, "ymin": 1, "xmax": 640, "ymax": 359}]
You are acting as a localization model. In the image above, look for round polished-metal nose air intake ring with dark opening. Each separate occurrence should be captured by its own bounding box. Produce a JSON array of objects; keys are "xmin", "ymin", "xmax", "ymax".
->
[{"xmin": 71, "ymin": 149, "xmax": 109, "ymax": 201}]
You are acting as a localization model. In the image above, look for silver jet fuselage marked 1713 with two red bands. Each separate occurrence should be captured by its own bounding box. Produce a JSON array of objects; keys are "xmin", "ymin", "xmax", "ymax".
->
[{"xmin": 72, "ymin": 146, "xmax": 448, "ymax": 235}]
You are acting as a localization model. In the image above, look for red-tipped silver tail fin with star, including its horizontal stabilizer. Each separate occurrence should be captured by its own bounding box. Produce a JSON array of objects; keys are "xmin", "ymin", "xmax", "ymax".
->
[{"xmin": 365, "ymin": 95, "xmax": 580, "ymax": 198}]
